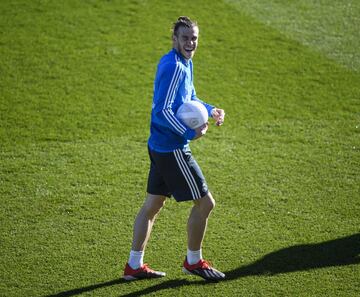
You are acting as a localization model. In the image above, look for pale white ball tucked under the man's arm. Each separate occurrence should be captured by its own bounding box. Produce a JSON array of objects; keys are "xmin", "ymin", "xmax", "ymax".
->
[{"xmin": 176, "ymin": 100, "xmax": 208, "ymax": 129}]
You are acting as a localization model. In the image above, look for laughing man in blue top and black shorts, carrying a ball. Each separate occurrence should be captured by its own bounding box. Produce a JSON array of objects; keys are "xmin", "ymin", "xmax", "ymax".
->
[{"xmin": 124, "ymin": 17, "xmax": 225, "ymax": 280}]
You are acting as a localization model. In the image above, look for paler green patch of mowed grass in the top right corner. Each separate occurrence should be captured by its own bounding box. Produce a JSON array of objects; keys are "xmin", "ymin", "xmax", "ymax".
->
[{"xmin": 226, "ymin": 0, "xmax": 360, "ymax": 71}]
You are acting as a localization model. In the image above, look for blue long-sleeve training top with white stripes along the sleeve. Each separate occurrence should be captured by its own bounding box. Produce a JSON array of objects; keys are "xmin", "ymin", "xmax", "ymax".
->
[{"xmin": 148, "ymin": 49, "xmax": 214, "ymax": 152}]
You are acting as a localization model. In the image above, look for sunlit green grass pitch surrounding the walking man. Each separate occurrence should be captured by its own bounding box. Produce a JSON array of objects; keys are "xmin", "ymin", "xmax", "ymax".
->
[{"xmin": 0, "ymin": 0, "xmax": 360, "ymax": 297}]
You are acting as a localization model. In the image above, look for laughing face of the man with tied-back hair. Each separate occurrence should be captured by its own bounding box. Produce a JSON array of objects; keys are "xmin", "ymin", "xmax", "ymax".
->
[{"xmin": 173, "ymin": 26, "xmax": 199, "ymax": 60}]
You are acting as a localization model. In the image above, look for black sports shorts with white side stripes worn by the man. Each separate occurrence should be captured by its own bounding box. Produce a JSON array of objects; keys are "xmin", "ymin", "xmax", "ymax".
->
[{"xmin": 147, "ymin": 148, "xmax": 209, "ymax": 202}]
